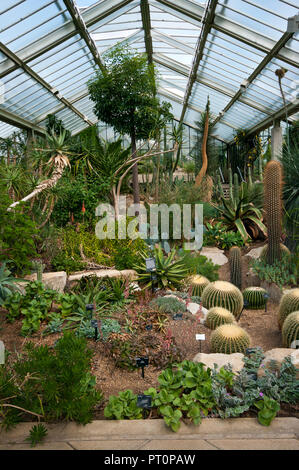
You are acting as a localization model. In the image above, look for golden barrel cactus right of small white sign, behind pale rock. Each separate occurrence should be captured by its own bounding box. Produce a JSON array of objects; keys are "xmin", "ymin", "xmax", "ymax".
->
[{"xmin": 211, "ymin": 324, "xmax": 251, "ymax": 354}]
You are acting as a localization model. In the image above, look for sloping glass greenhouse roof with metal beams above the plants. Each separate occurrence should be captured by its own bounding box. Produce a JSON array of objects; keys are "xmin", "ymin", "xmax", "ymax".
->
[{"xmin": 0, "ymin": 0, "xmax": 299, "ymax": 142}]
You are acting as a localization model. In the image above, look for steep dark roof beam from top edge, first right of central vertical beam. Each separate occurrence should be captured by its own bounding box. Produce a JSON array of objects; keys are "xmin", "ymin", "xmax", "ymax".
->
[{"xmin": 180, "ymin": 0, "xmax": 218, "ymax": 122}]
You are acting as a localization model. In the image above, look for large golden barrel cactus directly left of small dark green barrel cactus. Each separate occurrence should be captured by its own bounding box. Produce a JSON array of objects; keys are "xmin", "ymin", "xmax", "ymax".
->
[{"xmin": 201, "ymin": 281, "xmax": 244, "ymax": 318}]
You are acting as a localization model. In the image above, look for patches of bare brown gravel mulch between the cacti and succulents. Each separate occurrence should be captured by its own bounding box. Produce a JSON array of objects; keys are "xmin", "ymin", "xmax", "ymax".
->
[{"xmin": 0, "ymin": 247, "xmax": 298, "ymax": 419}]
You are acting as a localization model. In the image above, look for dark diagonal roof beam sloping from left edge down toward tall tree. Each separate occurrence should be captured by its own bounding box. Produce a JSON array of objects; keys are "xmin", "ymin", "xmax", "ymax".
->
[{"xmin": 0, "ymin": 42, "xmax": 94, "ymax": 126}]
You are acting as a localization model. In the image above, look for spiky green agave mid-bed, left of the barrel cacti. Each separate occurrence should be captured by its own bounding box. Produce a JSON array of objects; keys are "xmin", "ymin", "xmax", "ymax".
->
[{"xmin": 134, "ymin": 245, "xmax": 188, "ymax": 289}]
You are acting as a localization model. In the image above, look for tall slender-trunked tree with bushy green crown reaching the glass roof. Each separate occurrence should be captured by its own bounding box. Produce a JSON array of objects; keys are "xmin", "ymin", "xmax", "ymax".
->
[{"xmin": 88, "ymin": 46, "xmax": 173, "ymax": 204}]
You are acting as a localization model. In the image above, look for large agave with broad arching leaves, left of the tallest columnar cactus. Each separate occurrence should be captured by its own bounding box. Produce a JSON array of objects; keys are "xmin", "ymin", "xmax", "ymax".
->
[{"xmin": 218, "ymin": 180, "xmax": 267, "ymax": 242}]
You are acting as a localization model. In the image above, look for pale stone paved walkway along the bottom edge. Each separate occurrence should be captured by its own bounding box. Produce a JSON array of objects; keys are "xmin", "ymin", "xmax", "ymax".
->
[{"xmin": 0, "ymin": 418, "xmax": 299, "ymax": 450}]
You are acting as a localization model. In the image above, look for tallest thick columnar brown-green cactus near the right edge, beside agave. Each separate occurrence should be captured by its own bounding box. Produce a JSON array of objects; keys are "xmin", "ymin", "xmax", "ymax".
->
[{"xmin": 264, "ymin": 160, "xmax": 283, "ymax": 265}]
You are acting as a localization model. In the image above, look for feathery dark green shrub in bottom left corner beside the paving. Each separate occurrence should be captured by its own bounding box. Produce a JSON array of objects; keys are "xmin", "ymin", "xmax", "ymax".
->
[{"xmin": 0, "ymin": 333, "xmax": 103, "ymax": 434}]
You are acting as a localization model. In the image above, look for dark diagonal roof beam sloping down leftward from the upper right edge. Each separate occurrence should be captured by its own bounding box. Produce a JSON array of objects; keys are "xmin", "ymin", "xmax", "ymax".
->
[{"xmin": 213, "ymin": 33, "xmax": 294, "ymax": 125}]
